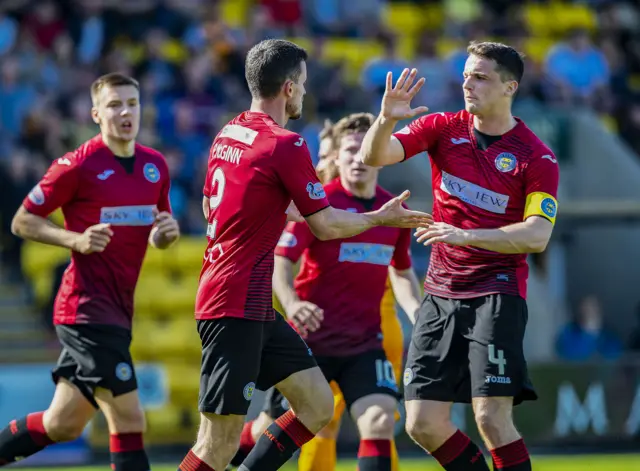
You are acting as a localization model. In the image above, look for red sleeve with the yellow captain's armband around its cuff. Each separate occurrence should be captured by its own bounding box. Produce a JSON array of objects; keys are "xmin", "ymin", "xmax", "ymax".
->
[{"xmin": 524, "ymin": 152, "xmax": 560, "ymax": 223}]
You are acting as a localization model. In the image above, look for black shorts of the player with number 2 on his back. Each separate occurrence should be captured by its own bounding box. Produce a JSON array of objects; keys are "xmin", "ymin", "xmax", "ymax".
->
[{"xmin": 197, "ymin": 313, "xmax": 317, "ymax": 415}]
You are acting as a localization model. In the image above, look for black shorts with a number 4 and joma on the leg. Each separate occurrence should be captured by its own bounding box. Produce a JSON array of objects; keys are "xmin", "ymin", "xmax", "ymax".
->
[{"xmin": 403, "ymin": 294, "xmax": 538, "ymax": 405}]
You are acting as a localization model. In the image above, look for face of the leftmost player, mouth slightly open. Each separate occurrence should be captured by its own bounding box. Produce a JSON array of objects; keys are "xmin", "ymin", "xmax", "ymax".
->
[{"xmin": 92, "ymin": 85, "xmax": 140, "ymax": 142}]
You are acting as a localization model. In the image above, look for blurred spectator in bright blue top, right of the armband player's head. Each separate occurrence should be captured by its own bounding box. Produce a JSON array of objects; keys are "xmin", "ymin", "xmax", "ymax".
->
[{"xmin": 545, "ymin": 29, "xmax": 610, "ymax": 105}]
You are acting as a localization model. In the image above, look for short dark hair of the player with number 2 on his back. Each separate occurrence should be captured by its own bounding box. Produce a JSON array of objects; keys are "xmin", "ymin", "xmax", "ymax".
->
[{"xmin": 245, "ymin": 39, "xmax": 308, "ymax": 98}]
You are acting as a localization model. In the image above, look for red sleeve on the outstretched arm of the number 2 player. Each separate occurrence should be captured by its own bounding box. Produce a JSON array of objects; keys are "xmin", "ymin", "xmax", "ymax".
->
[{"xmin": 275, "ymin": 134, "xmax": 329, "ymax": 217}]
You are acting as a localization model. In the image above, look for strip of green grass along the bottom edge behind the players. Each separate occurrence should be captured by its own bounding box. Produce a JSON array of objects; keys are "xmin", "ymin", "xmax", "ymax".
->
[{"xmin": 16, "ymin": 455, "xmax": 640, "ymax": 471}]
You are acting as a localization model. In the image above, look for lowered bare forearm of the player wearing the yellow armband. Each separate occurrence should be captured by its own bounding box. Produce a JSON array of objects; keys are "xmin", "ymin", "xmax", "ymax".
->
[{"xmin": 467, "ymin": 222, "xmax": 550, "ymax": 254}]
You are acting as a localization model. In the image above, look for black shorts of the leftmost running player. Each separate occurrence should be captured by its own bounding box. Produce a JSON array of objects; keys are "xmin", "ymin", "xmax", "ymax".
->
[{"xmin": 51, "ymin": 324, "xmax": 138, "ymax": 409}]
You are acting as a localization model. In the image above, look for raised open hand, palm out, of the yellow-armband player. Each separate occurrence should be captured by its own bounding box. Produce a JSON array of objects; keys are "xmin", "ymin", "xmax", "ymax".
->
[{"xmin": 380, "ymin": 69, "xmax": 429, "ymax": 121}]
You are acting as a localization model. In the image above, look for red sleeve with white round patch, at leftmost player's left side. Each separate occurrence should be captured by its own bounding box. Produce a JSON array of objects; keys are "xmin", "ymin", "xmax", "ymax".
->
[{"xmin": 22, "ymin": 154, "xmax": 79, "ymax": 217}]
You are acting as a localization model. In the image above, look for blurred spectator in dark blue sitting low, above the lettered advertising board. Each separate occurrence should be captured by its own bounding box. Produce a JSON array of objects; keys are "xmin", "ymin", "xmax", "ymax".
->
[{"xmin": 556, "ymin": 295, "xmax": 622, "ymax": 361}]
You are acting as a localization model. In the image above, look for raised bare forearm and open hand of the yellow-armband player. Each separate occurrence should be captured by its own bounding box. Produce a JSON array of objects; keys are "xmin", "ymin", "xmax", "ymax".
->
[{"xmin": 362, "ymin": 69, "xmax": 428, "ymax": 167}]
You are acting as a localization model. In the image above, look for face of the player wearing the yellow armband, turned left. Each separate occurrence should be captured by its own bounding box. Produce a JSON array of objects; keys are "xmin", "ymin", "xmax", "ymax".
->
[{"xmin": 462, "ymin": 54, "xmax": 518, "ymax": 116}]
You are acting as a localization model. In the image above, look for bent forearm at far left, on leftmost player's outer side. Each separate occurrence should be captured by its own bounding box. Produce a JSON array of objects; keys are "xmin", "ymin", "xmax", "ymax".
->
[{"xmin": 11, "ymin": 208, "xmax": 81, "ymax": 250}]
